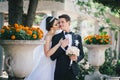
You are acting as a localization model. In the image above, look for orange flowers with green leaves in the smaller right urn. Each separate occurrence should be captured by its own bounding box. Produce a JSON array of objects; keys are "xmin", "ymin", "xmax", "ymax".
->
[{"xmin": 84, "ymin": 32, "xmax": 111, "ymax": 44}]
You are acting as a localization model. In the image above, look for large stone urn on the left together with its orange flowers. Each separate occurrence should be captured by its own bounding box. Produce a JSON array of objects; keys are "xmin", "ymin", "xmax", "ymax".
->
[{"xmin": 0, "ymin": 24, "xmax": 44, "ymax": 78}]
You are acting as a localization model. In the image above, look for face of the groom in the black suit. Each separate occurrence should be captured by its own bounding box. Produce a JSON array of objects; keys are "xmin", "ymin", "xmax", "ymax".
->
[{"xmin": 59, "ymin": 18, "xmax": 70, "ymax": 31}]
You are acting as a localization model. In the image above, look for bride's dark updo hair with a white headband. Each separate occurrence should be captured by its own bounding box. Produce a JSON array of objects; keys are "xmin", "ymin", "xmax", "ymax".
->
[{"xmin": 46, "ymin": 16, "xmax": 57, "ymax": 31}]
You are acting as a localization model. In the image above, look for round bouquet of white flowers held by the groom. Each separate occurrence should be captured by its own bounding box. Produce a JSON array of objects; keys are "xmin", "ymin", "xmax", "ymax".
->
[{"xmin": 66, "ymin": 46, "xmax": 80, "ymax": 66}]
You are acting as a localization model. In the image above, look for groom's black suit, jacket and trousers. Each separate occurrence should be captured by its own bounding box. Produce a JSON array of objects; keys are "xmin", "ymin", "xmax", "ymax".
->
[{"xmin": 51, "ymin": 31, "xmax": 84, "ymax": 80}]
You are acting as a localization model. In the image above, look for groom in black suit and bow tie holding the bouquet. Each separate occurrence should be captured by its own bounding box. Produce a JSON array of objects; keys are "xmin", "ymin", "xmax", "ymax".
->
[{"xmin": 51, "ymin": 14, "xmax": 84, "ymax": 80}]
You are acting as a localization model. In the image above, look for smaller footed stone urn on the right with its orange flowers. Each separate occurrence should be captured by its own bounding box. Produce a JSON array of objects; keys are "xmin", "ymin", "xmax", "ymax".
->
[{"xmin": 84, "ymin": 31, "xmax": 111, "ymax": 80}]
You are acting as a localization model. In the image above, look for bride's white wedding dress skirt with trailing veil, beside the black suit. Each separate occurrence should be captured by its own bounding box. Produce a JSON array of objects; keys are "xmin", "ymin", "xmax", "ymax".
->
[{"xmin": 25, "ymin": 45, "xmax": 56, "ymax": 80}]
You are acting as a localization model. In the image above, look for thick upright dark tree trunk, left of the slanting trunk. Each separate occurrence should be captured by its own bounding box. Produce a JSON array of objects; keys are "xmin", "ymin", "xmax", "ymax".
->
[{"xmin": 8, "ymin": 0, "xmax": 23, "ymax": 25}]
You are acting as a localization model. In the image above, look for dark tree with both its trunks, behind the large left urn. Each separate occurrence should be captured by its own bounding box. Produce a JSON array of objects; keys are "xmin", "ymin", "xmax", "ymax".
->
[{"xmin": 8, "ymin": 0, "xmax": 38, "ymax": 27}]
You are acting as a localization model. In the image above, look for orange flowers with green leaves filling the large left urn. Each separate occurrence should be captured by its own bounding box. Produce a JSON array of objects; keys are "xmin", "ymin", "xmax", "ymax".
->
[{"xmin": 0, "ymin": 24, "xmax": 43, "ymax": 40}]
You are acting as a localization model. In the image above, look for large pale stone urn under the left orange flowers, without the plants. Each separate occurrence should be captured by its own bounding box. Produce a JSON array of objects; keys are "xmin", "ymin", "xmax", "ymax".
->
[{"xmin": 0, "ymin": 40, "xmax": 45, "ymax": 78}]
